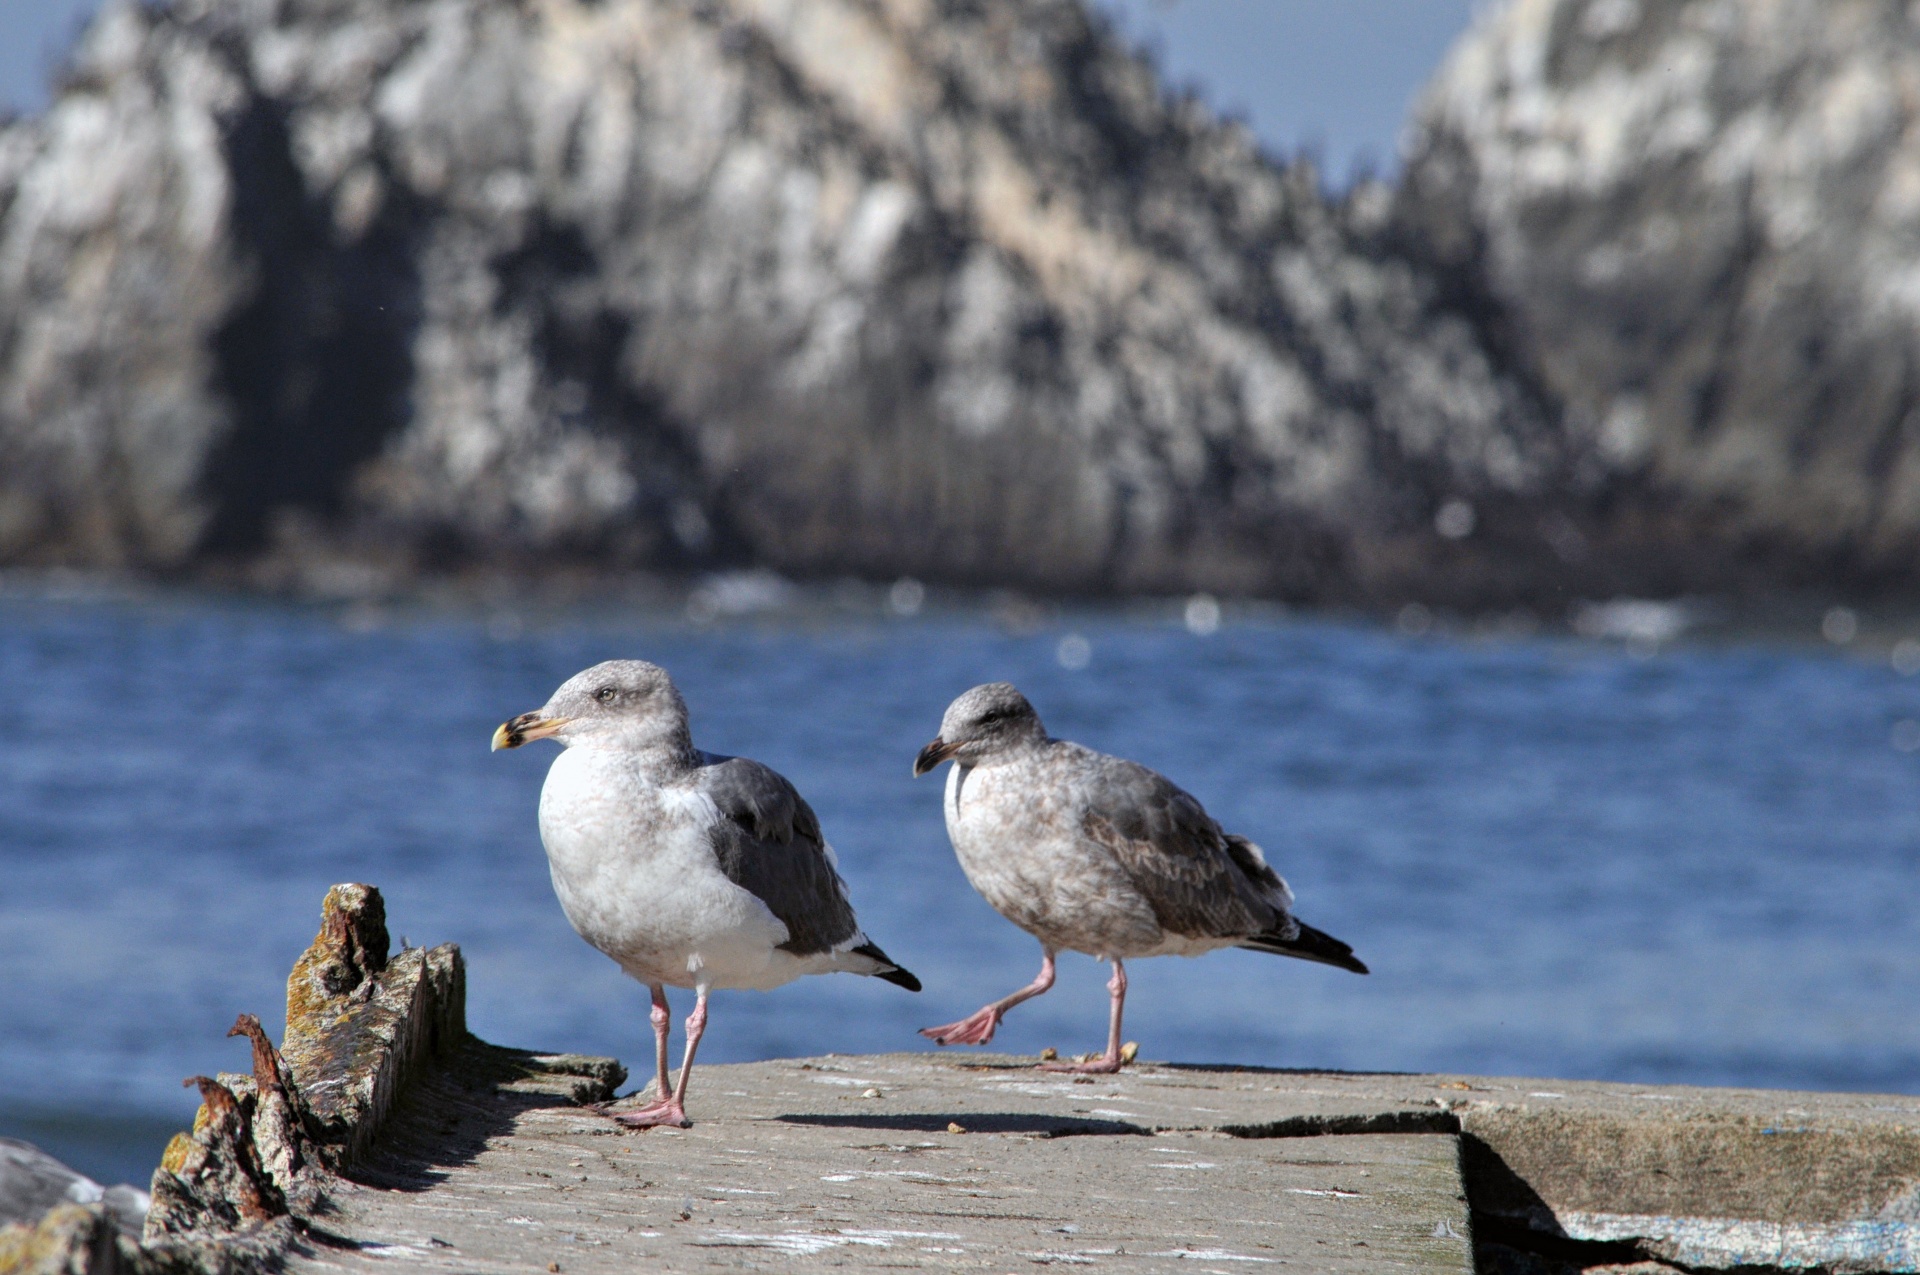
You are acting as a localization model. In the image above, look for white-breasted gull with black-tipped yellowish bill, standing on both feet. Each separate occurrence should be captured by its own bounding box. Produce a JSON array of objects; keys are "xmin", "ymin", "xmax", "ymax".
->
[{"xmin": 493, "ymin": 661, "xmax": 920, "ymax": 1129}]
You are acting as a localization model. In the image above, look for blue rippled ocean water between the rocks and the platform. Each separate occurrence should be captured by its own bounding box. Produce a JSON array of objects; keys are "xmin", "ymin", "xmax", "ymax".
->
[{"xmin": 0, "ymin": 593, "xmax": 1920, "ymax": 1181}]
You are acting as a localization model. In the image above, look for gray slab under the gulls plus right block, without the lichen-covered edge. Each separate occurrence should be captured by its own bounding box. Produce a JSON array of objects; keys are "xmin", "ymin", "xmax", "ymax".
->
[{"xmin": 280, "ymin": 1046, "xmax": 1920, "ymax": 1273}]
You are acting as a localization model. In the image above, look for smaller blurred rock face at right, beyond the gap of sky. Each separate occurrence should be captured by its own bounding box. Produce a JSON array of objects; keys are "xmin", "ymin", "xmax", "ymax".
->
[{"xmin": 1398, "ymin": 0, "xmax": 1920, "ymax": 588}]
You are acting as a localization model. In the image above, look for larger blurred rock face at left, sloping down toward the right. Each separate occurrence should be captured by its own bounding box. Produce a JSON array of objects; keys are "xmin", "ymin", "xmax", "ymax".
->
[{"xmin": 0, "ymin": 0, "xmax": 1567, "ymax": 595}]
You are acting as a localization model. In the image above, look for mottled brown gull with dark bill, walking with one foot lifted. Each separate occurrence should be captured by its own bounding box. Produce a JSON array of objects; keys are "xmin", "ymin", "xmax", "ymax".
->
[{"xmin": 914, "ymin": 682, "xmax": 1367, "ymax": 1071}]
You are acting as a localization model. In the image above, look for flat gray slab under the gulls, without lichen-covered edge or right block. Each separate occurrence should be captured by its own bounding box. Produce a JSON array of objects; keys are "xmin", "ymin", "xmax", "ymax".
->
[{"xmin": 292, "ymin": 1054, "xmax": 1473, "ymax": 1275}]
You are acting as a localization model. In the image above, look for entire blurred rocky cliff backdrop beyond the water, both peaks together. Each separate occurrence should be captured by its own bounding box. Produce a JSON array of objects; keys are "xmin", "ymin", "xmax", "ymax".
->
[{"xmin": 0, "ymin": 0, "xmax": 1920, "ymax": 605}]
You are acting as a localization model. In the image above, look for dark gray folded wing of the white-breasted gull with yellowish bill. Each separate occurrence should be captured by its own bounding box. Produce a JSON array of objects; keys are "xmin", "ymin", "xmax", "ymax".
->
[{"xmin": 693, "ymin": 753, "xmax": 860, "ymax": 956}]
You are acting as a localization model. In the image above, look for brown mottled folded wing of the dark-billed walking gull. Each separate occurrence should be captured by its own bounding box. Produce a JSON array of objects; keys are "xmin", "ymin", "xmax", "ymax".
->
[{"xmin": 1081, "ymin": 757, "xmax": 1292, "ymax": 939}]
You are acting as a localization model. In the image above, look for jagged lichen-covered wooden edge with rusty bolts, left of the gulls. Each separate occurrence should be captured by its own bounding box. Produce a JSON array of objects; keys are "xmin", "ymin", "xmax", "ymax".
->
[{"xmin": 0, "ymin": 885, "xmax": 583, "ymax": 1275}]
